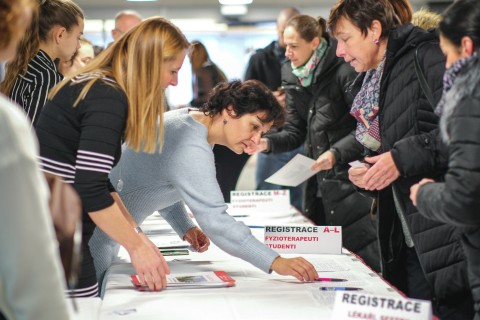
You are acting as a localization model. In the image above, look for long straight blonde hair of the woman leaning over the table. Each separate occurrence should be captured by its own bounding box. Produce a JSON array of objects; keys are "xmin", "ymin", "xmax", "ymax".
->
[{"xmin": 49, "ymin": 17, "xmax": 189, "ymax": 153}]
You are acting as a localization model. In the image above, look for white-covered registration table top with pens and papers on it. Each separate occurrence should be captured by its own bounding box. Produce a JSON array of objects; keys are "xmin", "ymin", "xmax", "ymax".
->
[{"xmin": 94, "ymin": 211, "xmax": 400, "ymax": 320}]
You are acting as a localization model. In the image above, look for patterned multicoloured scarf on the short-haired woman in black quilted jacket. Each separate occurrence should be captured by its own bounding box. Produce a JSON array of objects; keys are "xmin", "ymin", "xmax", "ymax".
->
[{"xmin": 350, "ymin": 56, "xmax": 386, "ymax": 151}]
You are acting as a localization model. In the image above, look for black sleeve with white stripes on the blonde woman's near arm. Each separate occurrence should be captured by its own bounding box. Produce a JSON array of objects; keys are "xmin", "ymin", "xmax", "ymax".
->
[{"xmin": 74, "ymin": 84, "xmax": 127, "ymax": 212}]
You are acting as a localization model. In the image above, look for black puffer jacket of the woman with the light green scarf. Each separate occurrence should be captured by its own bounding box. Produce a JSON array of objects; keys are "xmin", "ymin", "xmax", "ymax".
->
[{"xmin": 266, "ymin": 39, "xmax": 379, "ymax": 269}]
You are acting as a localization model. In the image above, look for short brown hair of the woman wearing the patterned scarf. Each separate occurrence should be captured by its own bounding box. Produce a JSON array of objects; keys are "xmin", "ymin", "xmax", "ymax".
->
[{"xmin": 328, "ymin": 0, "xmax": 404, "ymax": 38}]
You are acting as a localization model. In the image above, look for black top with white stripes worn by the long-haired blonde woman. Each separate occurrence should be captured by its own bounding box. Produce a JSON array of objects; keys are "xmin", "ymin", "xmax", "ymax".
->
[{"xmin": 36, "ymin": 75, "xmax": 128, "ymax": 232}]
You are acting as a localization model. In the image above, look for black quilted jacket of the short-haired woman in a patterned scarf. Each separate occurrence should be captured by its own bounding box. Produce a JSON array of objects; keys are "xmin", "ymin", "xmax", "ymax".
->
[{"xmin": 358, "ymin": 24, "xmax": 470, "ymax": 306}]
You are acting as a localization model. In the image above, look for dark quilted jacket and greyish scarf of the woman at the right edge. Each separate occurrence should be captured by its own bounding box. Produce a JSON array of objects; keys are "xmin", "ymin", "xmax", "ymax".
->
[{"xmin": 417, "ymin": 52, "xmax": 480, "ymax": 317}]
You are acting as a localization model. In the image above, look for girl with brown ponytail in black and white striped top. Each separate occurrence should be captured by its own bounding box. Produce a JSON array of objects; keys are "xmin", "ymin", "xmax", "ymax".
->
[{"xmin": 1, "ymin": 0, "xmax": 84, "ymax": 126}]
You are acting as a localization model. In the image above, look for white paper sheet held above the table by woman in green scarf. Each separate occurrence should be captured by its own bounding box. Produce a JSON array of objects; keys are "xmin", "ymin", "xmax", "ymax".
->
[{"xmin": 265, "ymin": 154, "xmax": 320, "ymax": 187}]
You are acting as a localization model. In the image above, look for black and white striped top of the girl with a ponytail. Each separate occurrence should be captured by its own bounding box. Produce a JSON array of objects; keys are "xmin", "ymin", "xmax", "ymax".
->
[{"xmin": 10, "ymin": 50, "xmax": 63, "ymax": 126}]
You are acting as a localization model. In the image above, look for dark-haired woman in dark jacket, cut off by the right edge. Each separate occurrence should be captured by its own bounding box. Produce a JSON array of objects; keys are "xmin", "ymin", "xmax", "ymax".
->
[{"xmin": 410, "ymin": 0, "xmax": 480, "ymax": 319}]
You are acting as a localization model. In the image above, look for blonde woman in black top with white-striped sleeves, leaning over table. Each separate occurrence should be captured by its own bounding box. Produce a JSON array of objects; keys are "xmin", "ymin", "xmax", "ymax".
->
[{"xmin": 36, "ymin": 17, "xmax": 189, "ymax": 296}]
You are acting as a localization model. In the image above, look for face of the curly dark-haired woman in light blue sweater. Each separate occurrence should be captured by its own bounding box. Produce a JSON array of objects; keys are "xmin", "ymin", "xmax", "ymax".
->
[{"xmin": 223, "ymin": 108, "xmax": 273, "ymax": 154}]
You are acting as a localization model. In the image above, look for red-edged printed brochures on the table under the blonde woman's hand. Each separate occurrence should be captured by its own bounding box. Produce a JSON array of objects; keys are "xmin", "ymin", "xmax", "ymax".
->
[{"xmin": 131, "ymin": 271, "xmax": 235, "ymax": 291}]
